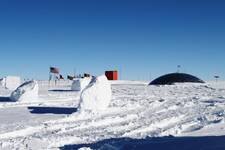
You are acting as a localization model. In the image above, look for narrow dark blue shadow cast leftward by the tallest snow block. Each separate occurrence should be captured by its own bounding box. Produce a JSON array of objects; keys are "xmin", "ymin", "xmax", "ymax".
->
[{"xmin": 27, "ymin": 107, "xmax": 77, "ymax": 114}]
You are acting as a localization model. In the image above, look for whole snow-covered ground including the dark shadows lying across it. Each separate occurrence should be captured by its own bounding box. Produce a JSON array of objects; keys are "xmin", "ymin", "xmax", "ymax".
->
[{"xmin": 0, "ymin": 81, "xmax": 225, "ymax": 150}]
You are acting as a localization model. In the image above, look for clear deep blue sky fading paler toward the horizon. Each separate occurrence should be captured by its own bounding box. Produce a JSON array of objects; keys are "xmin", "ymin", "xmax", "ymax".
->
[{"xmin": 0, "ymin": 0, "xmax": 225, "ymax": 80}]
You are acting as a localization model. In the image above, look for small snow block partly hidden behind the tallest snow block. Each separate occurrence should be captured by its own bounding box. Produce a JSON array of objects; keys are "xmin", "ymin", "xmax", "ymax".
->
[{"xmin": 71, "ymin": 78, "xmax": 91, "ymax": 91}]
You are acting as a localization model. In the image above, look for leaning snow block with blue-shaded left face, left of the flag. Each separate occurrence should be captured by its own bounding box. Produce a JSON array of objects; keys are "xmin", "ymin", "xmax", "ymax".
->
[{"xmin": 10, "ymin": 81, "xmax": 38, "ymax": 102}]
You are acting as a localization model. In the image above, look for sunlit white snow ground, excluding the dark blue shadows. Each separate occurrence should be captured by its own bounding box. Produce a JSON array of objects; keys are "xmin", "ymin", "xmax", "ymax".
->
[{"xmin": 0, "ymin": 81, "xmax": 225, "ymax": 149}]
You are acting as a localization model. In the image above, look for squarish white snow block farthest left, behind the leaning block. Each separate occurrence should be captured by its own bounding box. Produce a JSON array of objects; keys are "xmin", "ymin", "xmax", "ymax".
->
[{"xmin": 3, "ymin": 76, "xmax": 21, "ymax": 90}]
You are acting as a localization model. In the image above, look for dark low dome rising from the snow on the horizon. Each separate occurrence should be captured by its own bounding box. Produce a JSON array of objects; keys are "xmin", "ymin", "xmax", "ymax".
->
[{"xmin": 149, "ymin": 73, "xmax": 205, "ymax": 85}]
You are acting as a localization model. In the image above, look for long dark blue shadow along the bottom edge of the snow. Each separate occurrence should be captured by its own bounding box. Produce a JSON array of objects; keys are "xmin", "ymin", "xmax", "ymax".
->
[{"xmin": 60, "ymin": 136, "xmax": 225, "ymax": 150}]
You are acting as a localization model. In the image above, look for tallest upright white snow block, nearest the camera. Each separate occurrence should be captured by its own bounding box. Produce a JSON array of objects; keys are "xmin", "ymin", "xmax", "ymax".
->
[{"xmin": 79, "ymin": 75, "xmax": 112, "ymax": 112}]
